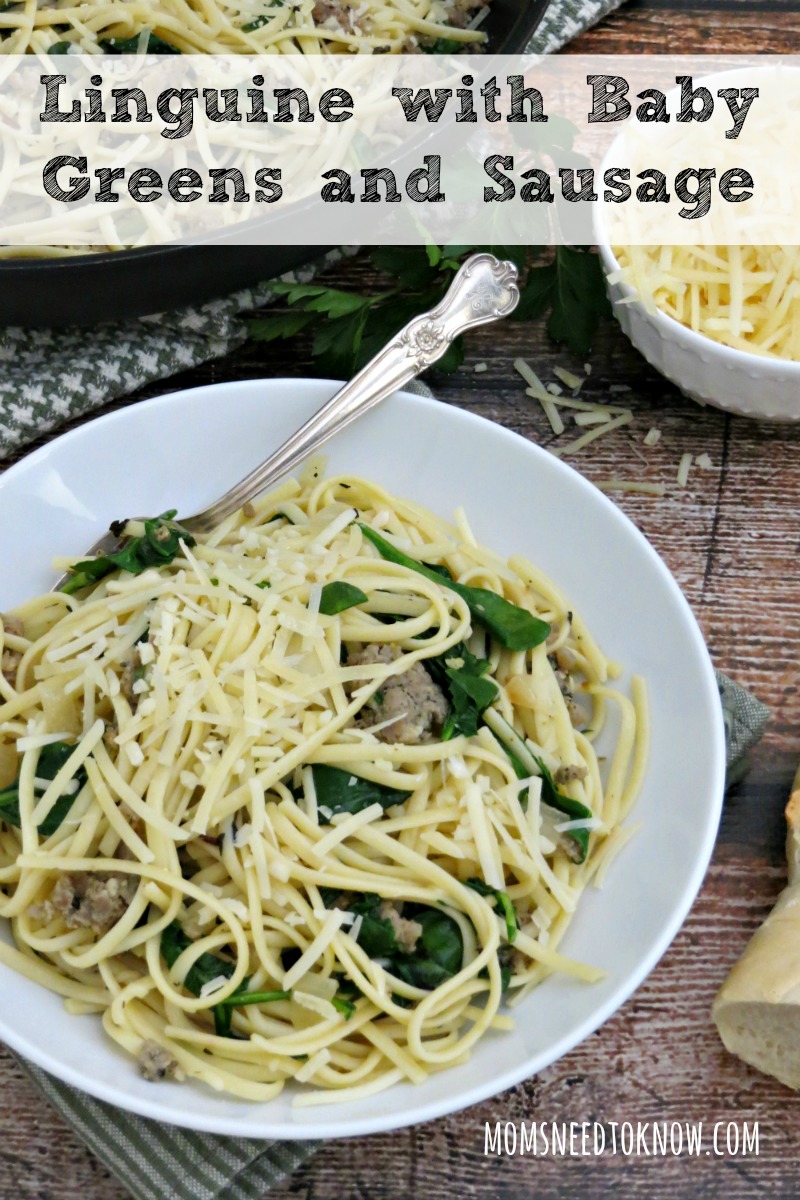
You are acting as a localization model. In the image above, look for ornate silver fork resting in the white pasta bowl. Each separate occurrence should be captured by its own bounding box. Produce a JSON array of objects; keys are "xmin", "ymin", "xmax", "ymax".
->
[{"xmin": 50, "ymin": 254, "xmax": 519, "ymax": 592}]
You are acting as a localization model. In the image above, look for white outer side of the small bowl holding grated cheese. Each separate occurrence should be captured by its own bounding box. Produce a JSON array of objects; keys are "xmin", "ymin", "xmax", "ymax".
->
[{"xmin": 597, "ymin": 242, "xmax": 800, "ymax": 421}]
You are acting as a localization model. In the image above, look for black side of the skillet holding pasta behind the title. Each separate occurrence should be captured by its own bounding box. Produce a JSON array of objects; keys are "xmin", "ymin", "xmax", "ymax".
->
[{"xmin": 0, "ymin": 0, "xmax": 548, "ymax": 328}]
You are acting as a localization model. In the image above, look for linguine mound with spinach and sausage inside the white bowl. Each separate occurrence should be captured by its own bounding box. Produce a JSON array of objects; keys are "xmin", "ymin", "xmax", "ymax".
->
[{"xmin": 0, "ymin": 462, "xmax": 646, "ymax": 1104}]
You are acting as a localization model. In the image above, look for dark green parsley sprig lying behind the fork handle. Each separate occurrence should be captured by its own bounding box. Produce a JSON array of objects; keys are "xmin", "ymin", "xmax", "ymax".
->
[{"xmin": 248, "ymin": 246, "xmax": 608, "ymax": 378}]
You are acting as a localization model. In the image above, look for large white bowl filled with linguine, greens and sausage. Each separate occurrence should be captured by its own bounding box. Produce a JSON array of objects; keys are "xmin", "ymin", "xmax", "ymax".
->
[{"xmin": 0, "ymin": 380, "xmax": 724, "ymax": 1139}]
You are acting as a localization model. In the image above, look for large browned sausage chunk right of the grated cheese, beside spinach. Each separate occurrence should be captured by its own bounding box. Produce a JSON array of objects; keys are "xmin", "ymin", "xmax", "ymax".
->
[{"xmin": 348, "ymin": 644, "xmax": 450, "ymax": 745}]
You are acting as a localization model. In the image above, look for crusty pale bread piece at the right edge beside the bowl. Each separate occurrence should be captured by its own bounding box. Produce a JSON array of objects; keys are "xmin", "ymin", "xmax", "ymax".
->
[{"xmin": 711, "ymin": 770, "xmax": 800, "ymax": 1088}]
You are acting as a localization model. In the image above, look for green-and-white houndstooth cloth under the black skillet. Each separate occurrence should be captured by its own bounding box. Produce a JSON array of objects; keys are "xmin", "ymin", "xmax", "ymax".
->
[{"xmin": 0, "ymin": 0, "xmax": 624, "ymax": 460}]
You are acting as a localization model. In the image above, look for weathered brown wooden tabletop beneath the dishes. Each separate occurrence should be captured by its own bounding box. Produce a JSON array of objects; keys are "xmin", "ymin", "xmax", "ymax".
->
[{"xmin": 6, "ymin": 0, "xmax": 800, "ymax": 1200}]
